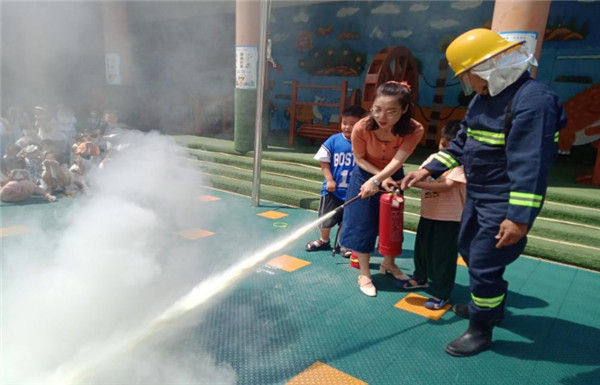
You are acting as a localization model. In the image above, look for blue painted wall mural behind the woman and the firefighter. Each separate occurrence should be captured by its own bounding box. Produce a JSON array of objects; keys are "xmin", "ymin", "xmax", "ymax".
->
[{"xmin": 268, "ymin": 0, "xmax": 600, "ymax": 155}]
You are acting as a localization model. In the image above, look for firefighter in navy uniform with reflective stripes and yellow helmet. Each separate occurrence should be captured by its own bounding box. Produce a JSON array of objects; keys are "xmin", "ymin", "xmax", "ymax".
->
[{"xmin": 401, "ymin": 29, "xmax": 566, "ymax": 356}]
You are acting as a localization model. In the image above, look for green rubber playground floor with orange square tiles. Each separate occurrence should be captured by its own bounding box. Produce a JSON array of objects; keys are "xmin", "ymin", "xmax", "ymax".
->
[{"xmin": 0, "ymin": 189, "xmax": 600, "ymax": 385}]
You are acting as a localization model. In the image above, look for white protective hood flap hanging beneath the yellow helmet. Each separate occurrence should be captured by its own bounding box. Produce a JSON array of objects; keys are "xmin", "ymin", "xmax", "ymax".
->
[{"xmin": 471, "ymin": 46, "xmax": 538, "ymax": 96}]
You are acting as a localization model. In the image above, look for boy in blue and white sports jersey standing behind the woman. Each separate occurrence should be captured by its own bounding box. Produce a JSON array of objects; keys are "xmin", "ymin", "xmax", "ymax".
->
[{"xmin": 306, "ymin": 106, "xmax": 365, "ymax": 257}]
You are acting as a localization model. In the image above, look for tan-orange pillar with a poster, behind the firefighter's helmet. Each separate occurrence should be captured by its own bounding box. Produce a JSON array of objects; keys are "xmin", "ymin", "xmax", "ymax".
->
[{"xmin": 492, "ymin": 0, "xmax": 550, "ymax": 76}]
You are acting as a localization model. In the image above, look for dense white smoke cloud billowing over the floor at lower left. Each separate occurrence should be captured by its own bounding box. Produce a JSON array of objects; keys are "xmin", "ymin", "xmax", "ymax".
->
[{"xmin": 0, "ymin": 131, "xmax": 236, "ymax": 384}]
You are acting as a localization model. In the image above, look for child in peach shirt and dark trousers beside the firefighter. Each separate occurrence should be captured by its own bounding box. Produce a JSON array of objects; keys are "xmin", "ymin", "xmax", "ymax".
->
[{"xmin": 399, "ymin": 121, "xmax": 466, "ymax": 310}]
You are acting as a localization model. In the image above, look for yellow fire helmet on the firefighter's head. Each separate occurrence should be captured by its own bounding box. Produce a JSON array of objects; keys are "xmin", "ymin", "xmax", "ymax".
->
[{"xmin": 446, "ymin": 28, "xmax": 521, "ymax": 77}]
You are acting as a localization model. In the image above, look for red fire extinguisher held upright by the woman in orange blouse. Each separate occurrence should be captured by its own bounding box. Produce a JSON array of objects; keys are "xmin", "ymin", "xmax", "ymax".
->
[{"xmin": 378, "ymin": 190, "xmax": 404, "ymax": 256}]
